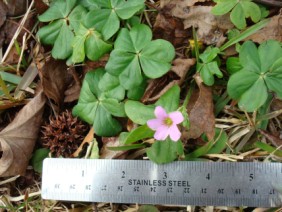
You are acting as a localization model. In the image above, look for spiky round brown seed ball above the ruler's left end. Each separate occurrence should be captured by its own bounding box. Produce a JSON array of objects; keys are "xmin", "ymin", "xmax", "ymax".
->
[{"xmin": 41, "ymin": 110, "xmax": 89, "ymax": 157}]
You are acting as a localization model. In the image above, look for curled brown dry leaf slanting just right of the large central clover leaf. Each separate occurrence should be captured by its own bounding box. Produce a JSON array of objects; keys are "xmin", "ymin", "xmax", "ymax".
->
[{"xmin": 141, "ymin": 58, "xmax": 196, "ymax": 103}]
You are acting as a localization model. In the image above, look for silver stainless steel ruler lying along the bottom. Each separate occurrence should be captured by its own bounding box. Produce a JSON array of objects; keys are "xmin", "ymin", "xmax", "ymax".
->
[{"xmin": 42, "ymin": 158, "xmax": 282, "ymax": 207}]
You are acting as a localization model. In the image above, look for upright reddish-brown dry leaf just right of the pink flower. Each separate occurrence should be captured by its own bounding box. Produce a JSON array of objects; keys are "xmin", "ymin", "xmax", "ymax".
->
[{"xmin": 184, "ymin": 73, "xmax": 215, "ymax": 140}]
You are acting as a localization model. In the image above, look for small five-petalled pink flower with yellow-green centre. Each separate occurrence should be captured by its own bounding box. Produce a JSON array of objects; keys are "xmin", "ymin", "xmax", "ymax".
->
[{"xmin": 147, "ymin": 106, "xmax": 184, "ymax": 141}]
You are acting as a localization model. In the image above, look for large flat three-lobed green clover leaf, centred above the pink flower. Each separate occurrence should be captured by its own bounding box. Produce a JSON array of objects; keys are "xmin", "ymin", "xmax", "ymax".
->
[{"xmin": 106, "ymin": 24, "xmax": 175, "ymax": 90}]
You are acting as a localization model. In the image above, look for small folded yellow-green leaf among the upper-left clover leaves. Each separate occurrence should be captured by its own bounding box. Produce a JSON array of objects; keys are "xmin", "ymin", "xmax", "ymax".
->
[{"xmin": 72, "ymin": 25, "xmax": 112, "ymax": 63}]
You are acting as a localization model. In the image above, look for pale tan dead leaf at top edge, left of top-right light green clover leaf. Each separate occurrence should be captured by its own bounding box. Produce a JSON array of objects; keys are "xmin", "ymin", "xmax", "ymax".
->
[{"xmin": 162, "ymin": 0, "xmax": 234, "ymax": 46}]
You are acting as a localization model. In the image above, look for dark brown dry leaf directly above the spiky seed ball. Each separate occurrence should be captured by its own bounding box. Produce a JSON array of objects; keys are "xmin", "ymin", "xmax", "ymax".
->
[{"xmin": 39, "ymin": 58, "xmax": 73, "ymax": 112}]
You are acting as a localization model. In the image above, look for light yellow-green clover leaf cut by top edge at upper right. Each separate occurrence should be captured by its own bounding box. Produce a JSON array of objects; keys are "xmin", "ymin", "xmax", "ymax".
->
[{"xmin": 212, "ymin": 0, "xmax": 262, "ymax": 29}]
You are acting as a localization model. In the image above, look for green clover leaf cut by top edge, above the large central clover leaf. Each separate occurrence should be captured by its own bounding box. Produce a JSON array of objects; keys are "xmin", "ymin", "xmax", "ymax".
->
[{"xmin": 85, "ymin": 0, "xmax": 144, "ymax": 40}]
